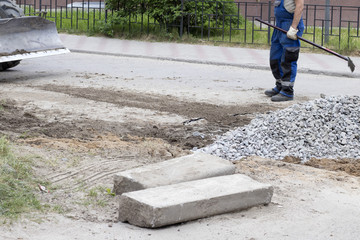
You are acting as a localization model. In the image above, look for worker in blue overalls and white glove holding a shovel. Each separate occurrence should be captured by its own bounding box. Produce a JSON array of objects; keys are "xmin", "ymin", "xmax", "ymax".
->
[{"xmin": 265, "ymin": 0, "xmax": 304, "ymax": 102}]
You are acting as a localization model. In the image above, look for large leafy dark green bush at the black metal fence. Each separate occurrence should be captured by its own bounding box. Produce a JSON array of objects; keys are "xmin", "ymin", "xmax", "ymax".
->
[{"xmin": 102, "ymin": 0, "xmax": 239, "ymax": 35}]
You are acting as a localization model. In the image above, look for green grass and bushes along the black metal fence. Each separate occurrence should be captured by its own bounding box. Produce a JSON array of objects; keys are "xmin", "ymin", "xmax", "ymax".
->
[{"xmin": 19, "ymin": 0, "xmax": 360, "ymax": 55}]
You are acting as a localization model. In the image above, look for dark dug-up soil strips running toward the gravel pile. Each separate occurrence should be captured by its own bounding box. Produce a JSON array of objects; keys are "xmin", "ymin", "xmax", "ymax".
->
[{"xmin": 0, "ymin": 85, "xmax": 274, "ymax": 150}]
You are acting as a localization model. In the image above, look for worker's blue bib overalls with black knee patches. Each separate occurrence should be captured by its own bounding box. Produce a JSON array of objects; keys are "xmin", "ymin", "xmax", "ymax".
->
[{"xmin": 270, "ymin": 0, "xmax": 304, "ymax": 97}]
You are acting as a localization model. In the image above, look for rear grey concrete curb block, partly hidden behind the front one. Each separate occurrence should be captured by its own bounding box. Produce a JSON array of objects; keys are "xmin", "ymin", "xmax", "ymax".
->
[{"xmin": 114, "ymin": 153, "xmax": 235, "ymax": 195}]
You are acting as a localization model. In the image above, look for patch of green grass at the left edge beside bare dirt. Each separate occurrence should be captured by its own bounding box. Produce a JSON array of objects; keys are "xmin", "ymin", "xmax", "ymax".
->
[{"xmin": 0, "ymin": 137, "xmax": 42, "ymax": 223}]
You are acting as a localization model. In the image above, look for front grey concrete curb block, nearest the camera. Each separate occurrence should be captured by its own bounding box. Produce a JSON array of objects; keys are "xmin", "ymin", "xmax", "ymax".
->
[{"xmin": 119, "ymin": 174, "xmax": 273, "ymax": 228}]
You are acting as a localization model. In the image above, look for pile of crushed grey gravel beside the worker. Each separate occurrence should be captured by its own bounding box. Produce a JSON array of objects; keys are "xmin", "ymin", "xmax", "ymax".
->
[{"xmin": 200, "ymin": 96, "xmax": 360, "ymax": 161}]
